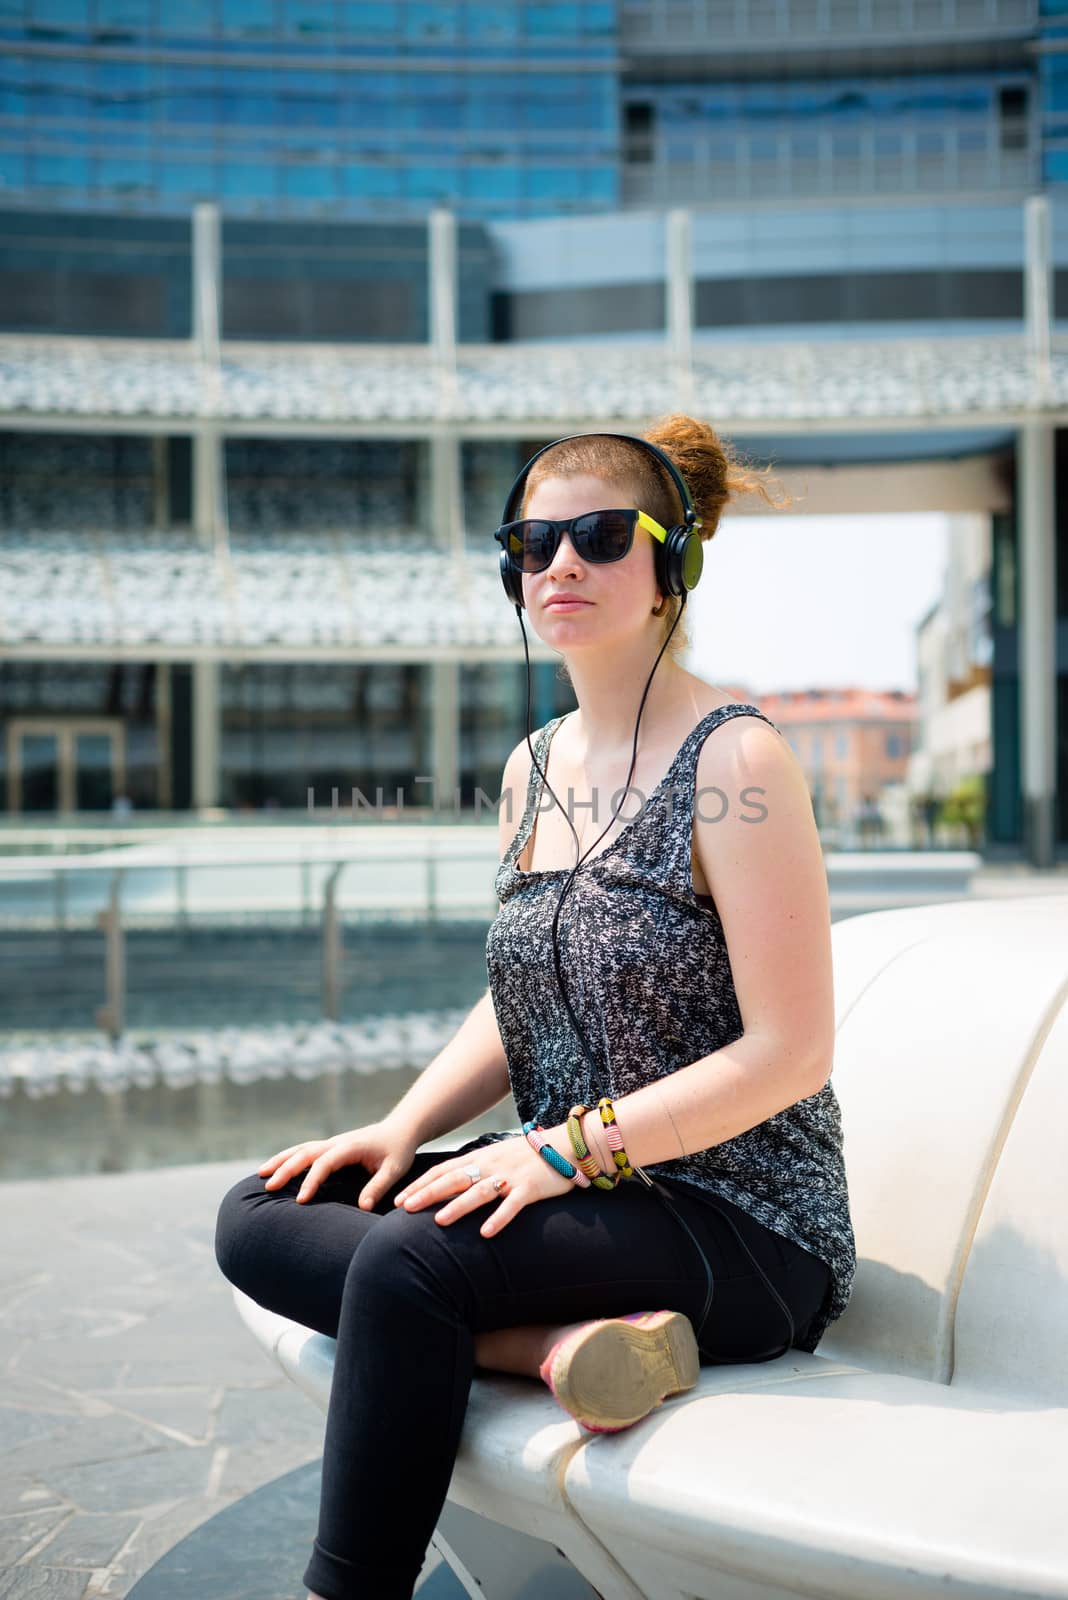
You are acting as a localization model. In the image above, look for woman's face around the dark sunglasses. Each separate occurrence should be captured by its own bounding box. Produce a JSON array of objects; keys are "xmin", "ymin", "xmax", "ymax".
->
[{"xmin": 523, "ymin": 474, "xmax": 660, "ymax": 651}]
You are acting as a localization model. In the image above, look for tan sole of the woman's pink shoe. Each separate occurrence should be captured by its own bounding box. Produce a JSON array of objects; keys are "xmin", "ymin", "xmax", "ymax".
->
[{"xmin": 544, "ymin": 1310, "xmax": 700, "ymax": 1432}]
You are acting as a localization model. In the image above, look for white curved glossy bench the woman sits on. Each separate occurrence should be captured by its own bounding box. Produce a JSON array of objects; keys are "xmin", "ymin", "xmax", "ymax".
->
[{"xmin": 235, "ymin": 894, "xmax": 1068, "ymax": 1600}]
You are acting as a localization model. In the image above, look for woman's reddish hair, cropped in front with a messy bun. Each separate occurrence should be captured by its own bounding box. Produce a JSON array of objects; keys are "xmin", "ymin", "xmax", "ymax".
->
[{"xmin": 516, "ymin": 413, "xmax": 791, "ymax": 658}]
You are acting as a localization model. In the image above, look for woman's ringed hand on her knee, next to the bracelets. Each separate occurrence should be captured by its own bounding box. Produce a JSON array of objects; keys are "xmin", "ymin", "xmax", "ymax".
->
[{"xmin": 395, "ymin": 1136, "xmax": 574, "ymax": 1238}]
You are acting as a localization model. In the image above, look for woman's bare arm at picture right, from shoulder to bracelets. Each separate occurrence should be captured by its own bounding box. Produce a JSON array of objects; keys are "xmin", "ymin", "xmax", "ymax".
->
[{"xmin": 547, "ymin": 717, "xmax": 835, "ymax": 1166}]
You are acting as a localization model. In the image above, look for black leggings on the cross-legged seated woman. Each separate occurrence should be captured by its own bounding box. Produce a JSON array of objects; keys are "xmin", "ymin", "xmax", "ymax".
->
[{"xmin": 216, "ymin": 1146, "xmax": 830, "ymax": 1600}]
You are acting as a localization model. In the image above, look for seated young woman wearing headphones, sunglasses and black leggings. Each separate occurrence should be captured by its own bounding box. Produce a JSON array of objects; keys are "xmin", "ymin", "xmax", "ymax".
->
[{"xmin": 216, "ymin": 418, "xmax": 855, "ymax": 1600}]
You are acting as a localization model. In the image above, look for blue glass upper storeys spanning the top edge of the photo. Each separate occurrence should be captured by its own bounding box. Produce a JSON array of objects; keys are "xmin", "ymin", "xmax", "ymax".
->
[{"xmin": 0, "ymin": 0, "xmax": 1048, "ymax": 221}]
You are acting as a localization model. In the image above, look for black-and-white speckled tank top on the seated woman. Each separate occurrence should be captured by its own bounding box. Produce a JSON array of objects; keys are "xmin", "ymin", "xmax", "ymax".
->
[{"xmin": 486, "ymin": 702, "xmax": 857, "ymax": 1350}]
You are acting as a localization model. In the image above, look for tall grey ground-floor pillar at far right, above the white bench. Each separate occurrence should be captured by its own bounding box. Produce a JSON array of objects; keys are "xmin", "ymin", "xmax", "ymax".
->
[{"xmin": 1017, "ymin": 422, "xmax": 1057, "ymax": 867}]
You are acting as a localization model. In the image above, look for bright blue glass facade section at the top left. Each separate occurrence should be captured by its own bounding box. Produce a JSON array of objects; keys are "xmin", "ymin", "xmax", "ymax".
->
[{"xmin": 0, "ymin": 0, "xmax": 619, "ymax": 218}]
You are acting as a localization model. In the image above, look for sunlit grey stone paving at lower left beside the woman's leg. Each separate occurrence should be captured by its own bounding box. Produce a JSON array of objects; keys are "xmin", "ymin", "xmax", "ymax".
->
[{"xmin": 0, "ymin": 1152, "xmax": 460, "ymax": 1600}]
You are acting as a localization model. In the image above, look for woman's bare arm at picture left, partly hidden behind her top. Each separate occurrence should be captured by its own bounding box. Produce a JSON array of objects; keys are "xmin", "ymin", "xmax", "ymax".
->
[{"xmin": 387, "ymin": 739, "xmax": 531, "ymax": 1144}]
